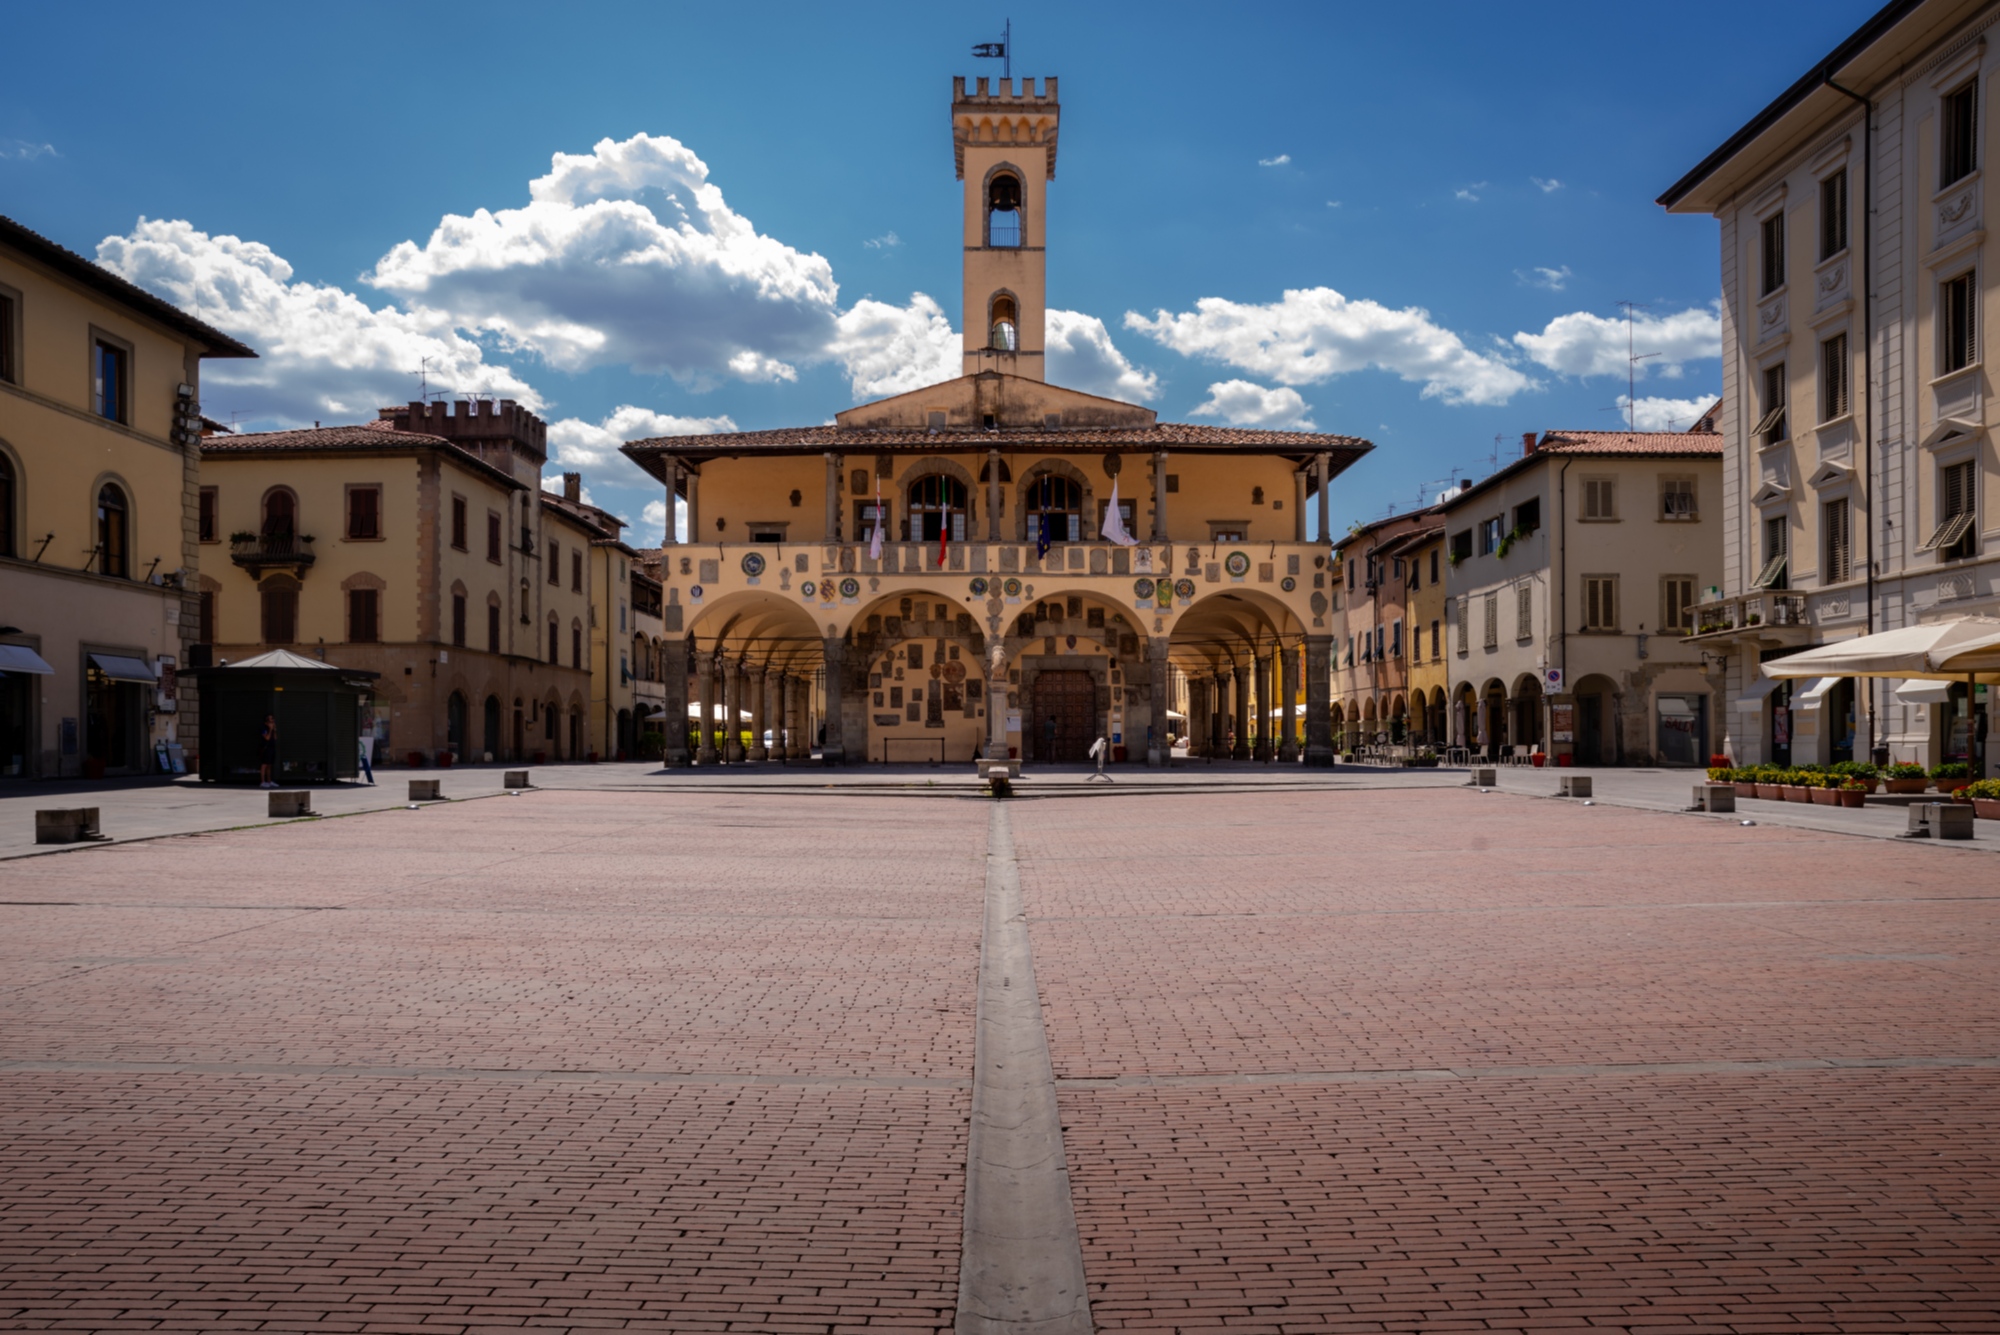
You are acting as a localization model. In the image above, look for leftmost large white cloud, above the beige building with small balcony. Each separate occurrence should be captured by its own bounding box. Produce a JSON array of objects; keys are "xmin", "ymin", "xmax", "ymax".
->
[{"xmin": 98, "ymin": 218, "xmax": 542, "ymax": 426}]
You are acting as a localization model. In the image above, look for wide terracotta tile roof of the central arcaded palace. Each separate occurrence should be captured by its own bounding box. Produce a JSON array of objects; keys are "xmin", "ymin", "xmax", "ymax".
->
[{"xmin": 620, "ymin": 422, "xmax": 1374, "ymax": 476}]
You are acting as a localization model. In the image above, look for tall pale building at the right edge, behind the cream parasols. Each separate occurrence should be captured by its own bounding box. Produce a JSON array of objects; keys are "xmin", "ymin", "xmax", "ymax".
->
[{"xmin": 1660, "ymin": 0, "xmax": 2000, "ymax": 765}]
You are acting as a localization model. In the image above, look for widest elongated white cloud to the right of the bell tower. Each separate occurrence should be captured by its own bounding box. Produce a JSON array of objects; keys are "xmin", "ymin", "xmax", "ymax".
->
[{"xmin": 1124, "ymin": 288, "xmax": 1536, "ymax": 404}]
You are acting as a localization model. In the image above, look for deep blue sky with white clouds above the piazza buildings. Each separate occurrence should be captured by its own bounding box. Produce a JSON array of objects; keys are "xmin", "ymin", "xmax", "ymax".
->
[{"xmin": 0, "ymin": 0, "xmax": 1874, "ymax": 542}]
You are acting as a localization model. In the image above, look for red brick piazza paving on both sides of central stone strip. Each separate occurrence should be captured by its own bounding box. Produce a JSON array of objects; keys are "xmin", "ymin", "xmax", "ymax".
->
[{"xmin": 0, "ymin": 787, "xmax": 2000, "ymax": 1331}]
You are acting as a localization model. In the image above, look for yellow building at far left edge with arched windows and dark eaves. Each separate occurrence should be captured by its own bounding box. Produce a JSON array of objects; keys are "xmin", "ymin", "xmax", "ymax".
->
[{"xmin": 0, "ymin": 218, "xmax": 256, "ymax": 779}]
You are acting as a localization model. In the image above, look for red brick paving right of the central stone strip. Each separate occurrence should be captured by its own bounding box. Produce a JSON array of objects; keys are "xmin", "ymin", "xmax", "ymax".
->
[{"xmin": 1016, "ymin": 793, "xmax": 2000, "ymax": 1333}]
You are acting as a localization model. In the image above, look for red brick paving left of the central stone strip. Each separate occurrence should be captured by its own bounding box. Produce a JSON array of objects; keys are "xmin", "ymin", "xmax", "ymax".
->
[{"xmin": 0, "ymin": 793, "xmax": 986, "ymax": 1331}]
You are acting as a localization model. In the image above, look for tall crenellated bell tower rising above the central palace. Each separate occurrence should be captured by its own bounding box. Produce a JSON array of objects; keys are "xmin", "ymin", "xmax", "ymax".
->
[{"xmin": 952, "ymin": 78, "xmax": 1062, "ymax": 380}]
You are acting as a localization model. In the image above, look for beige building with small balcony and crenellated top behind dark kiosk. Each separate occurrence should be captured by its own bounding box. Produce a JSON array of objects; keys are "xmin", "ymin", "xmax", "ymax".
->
[{"xmin": 200, "ymin": 402, "xmax": 606, "ymax": 765}]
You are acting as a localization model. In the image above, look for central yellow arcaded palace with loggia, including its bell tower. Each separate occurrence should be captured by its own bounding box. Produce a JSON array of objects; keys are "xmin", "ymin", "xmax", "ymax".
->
[{"xmin": 624, "ymin": 78, "xmax": 1370, "ymax": 763}]
